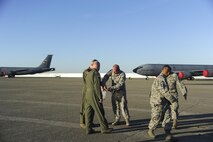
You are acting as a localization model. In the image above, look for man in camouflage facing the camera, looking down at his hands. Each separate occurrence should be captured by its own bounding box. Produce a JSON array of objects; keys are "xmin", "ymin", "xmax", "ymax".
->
[{"xmin": 102, "ymin": 64, "xmax": 130, "ymax": 126}]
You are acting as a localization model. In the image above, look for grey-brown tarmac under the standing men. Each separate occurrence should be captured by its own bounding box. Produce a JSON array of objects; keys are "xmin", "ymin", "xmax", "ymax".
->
[{"xmin": 0, "ymin": 78, "xmax": 213, "ymax": 142}]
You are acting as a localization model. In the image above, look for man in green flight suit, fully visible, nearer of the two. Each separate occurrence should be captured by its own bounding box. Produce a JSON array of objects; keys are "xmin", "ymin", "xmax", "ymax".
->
[{"xmin": 85, "ymin": 61, "xmax": 112, "ymax": 134}]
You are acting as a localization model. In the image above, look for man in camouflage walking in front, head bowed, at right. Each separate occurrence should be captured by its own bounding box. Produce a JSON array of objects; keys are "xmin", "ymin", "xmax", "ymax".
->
[{"xmin": 148, "ymin": 65, "xmax": 176, "ymax": 140}]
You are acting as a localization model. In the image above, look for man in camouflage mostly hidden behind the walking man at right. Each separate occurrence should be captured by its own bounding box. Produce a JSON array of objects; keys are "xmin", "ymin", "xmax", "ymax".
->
[{"xmin": 162, "ymin": 73, "xmax": 187, "ymax": 129}]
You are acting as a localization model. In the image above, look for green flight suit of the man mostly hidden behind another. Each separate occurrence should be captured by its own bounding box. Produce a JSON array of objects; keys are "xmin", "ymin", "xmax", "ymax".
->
[{"xmin": 80, "ymin": 68, "xmax": 94, "ymax": 125}]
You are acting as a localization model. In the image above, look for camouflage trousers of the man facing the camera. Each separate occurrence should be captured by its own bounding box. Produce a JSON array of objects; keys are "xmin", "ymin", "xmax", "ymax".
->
[{"xmin": 111, "ymin": 92, "xmax": 130, "ymax": 121}]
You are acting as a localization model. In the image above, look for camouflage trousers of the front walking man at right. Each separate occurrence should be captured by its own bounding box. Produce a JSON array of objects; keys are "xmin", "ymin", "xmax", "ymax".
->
[{"xmin": 149, "ymin": 103, "xmax": 172, "ymax": 131}]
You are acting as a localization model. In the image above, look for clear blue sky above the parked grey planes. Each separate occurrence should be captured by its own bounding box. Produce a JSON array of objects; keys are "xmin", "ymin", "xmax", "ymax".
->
[{"xmin": 0, "ymin": 0, "xmax": 213, "ymax": 72}]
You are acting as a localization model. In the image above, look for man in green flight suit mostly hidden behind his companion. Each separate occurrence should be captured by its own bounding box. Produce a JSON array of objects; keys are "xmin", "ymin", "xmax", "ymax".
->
[{"xmin": 80, "ymin": 59, "xmax": 97, "ymax": 129}]
